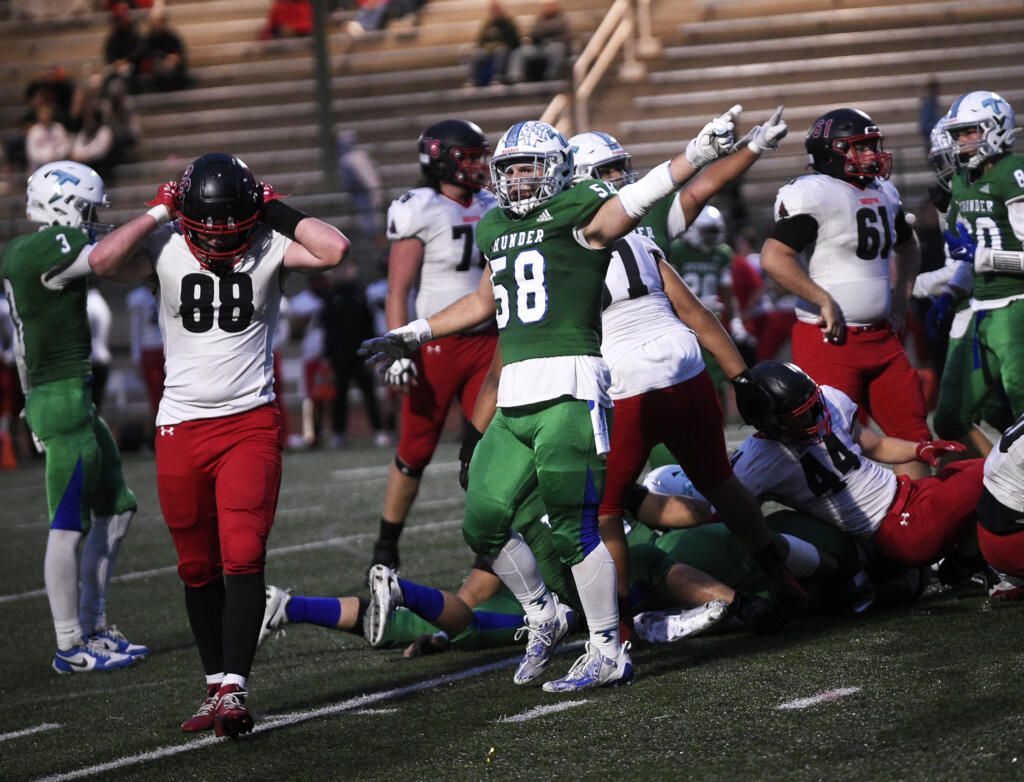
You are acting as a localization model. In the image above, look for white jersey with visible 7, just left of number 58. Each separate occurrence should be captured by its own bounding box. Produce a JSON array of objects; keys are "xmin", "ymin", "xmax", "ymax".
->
[{"xmin": 387, "ymin": 187, "xmax": 497, "ymax": 328}]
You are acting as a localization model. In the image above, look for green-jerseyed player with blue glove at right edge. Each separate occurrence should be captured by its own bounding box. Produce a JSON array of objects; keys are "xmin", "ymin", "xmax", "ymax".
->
[{"xmin": 945, "ymin": 90, "xmax": 1024, "ymax": 423}]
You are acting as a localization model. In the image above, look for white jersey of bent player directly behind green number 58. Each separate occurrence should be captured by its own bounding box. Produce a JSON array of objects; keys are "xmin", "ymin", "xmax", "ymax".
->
[{"xmin": 601, "ymin": 233, "xmax": 705, "ymax": 399}]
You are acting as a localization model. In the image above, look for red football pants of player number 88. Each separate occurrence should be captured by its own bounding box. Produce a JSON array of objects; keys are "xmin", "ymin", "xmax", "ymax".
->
[{"xmin": 157, "ymin": 404, "xmax": 281, "ymax": 587}]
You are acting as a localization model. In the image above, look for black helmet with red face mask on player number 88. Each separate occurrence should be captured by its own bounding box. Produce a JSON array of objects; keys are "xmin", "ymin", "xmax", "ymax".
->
[{"xmin": 178, "ymin": 153, "xmax": 263, "ymax": 273}]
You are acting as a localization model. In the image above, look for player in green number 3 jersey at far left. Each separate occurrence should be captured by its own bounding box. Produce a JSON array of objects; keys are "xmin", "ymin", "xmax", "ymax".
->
[{"xmin": 0, "ymin": 161, "xmax": 150, "ymax": 674}]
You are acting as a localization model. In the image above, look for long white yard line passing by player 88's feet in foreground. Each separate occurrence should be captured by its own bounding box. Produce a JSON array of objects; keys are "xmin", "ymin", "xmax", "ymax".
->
[{"xmin": 37, "ymin": 657, "xmax": 521, "ymax": 782}]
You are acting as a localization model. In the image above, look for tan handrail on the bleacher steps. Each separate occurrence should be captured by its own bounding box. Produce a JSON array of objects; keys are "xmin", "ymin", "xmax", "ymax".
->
[{"xmin": 541, "ymin": 0, "xmax": 660, "ymax": 135}]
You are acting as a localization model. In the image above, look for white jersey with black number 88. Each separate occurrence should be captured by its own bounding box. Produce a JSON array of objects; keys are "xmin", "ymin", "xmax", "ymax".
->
[{"xmin": 142, "ymin": 223, "xmax": 292, "ymax": 426}]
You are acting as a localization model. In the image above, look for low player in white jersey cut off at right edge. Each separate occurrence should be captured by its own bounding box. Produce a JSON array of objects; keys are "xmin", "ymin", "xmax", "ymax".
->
[{"xmin": 978, "ymin": 416, "xmax": 1024, "ymax": 600}]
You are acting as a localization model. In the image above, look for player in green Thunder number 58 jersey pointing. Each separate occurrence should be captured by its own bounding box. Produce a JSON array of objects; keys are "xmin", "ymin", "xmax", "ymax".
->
[{"xmin": 364, "ymin": 106, "xmax": 770, "ymax": 692}]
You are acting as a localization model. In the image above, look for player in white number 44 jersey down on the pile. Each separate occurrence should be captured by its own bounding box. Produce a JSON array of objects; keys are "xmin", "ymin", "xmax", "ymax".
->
[{"xmin": 732, "ymin": 361, "xmax": 982, "ymax": 565}]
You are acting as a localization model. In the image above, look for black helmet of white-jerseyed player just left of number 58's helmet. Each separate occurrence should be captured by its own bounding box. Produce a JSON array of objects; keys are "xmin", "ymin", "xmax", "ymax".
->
[{"xmin": 416, "ymin": 120, "xmax": 490, "ymax": 191}]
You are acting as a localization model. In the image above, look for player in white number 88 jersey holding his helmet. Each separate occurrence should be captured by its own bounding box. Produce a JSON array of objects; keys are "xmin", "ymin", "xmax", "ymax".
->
[{"xmin": 89, "ymin": 154, "xmax": 348, "ymax": 736}]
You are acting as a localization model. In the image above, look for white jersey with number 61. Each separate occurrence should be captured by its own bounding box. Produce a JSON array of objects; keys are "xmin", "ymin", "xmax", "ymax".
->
[{"xmin": 775, "ymin": 174, "xmax": 902, "ymax": 325}]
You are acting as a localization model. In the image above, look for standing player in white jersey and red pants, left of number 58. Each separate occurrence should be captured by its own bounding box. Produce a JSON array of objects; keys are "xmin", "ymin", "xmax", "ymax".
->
[{"xmin": 371, "ymin": 120, "xmax": 498, "ymax": 569}]
